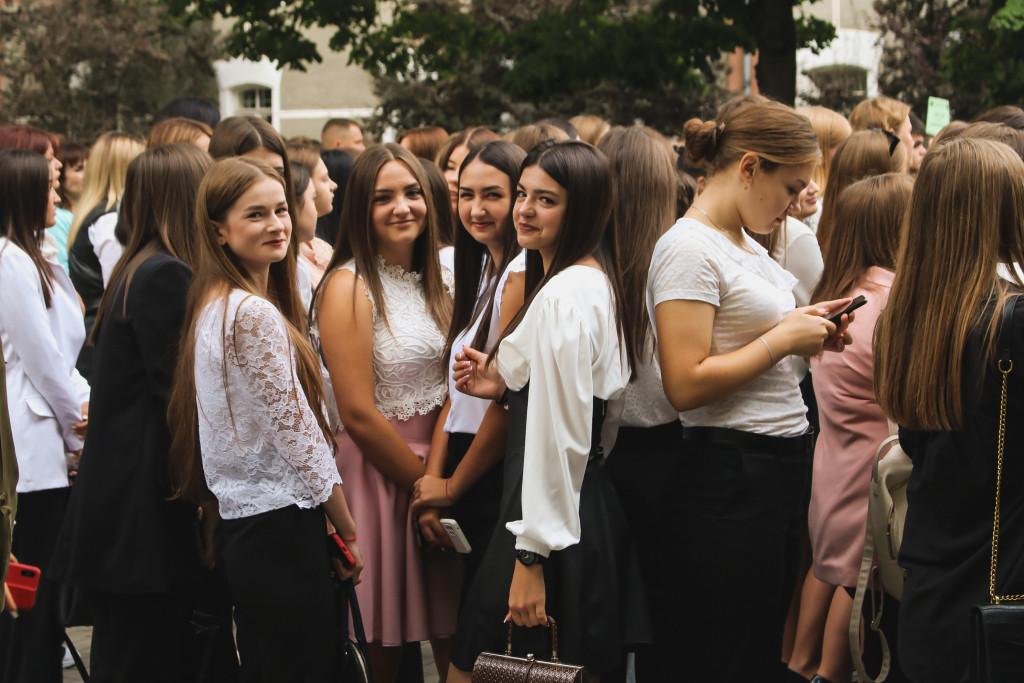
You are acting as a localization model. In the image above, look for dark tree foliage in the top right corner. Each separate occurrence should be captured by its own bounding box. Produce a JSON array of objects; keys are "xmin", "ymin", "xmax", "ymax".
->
[{"xmin": 874, "ymin": 0, "xmax": 1024, "ymax": 120}]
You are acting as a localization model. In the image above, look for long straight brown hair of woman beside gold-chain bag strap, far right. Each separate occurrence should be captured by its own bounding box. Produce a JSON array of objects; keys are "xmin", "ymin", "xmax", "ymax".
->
[{"xmin": 874, "ymin": 138, "xmax": 1024, "ymax": 431}]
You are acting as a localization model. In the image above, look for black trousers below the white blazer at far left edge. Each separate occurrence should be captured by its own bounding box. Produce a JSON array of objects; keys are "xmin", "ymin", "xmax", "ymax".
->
[{"xmin": 0, "ymin": 487, "xmax": 71, "ymax": 683}]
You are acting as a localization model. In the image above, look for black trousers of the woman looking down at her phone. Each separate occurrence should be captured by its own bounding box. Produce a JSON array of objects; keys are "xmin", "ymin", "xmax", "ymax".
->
[{"xmin": 668, "ymin": 429, "xmax": 813, "ymax": 683}]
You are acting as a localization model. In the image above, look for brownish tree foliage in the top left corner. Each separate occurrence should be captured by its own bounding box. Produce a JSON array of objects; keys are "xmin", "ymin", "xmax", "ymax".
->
[{"xmin": 0, "ymin": 0, "xmax": 222, "ymax": 140}]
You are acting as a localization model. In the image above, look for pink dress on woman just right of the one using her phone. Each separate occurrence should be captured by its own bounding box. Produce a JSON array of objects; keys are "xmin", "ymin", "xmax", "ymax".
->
[{"xmin": 808, "ymin": 266, "xmax": 894, "ymax": 588}]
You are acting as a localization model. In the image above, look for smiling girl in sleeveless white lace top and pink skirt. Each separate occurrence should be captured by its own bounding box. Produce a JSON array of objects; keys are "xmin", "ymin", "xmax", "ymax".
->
[{"xmin": 312, "ymin": 143, "xmax": 461, "ymax": 683}]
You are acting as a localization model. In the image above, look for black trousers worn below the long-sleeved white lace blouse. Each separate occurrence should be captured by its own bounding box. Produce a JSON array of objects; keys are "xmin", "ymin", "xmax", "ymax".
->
[{"xmin": 216, "ymin": 506, "xmax": 340, "ymax": 683}]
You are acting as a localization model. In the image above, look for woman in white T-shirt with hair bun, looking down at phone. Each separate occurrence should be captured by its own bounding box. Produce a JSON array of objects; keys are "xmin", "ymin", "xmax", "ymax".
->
[{"xmin": 647, "ymin": 102, "xmax": 850, "ymax": 682}]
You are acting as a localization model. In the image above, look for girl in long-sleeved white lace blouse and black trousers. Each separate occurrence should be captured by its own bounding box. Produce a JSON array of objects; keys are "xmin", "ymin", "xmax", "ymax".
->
[{"xmin": 169, "ymin": 158, "xmax": 361, "ymax": 681}]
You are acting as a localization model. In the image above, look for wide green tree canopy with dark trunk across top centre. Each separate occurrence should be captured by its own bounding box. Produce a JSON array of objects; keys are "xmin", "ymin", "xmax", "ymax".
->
[{"xmin": 174, "ymin": 0, "xmax": 835, "ymax": 132}]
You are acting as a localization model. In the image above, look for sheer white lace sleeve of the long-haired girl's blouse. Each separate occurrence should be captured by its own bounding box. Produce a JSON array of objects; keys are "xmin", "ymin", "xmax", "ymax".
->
[{"xmin": 224, "ymin": 297, "xmax": 341, "ymax": 504}]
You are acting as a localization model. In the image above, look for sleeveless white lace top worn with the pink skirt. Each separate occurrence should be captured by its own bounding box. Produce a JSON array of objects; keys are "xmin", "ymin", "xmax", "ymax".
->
[{"xmin": 333, "ymin": 257, "xmax": 455, "ymax": 420}]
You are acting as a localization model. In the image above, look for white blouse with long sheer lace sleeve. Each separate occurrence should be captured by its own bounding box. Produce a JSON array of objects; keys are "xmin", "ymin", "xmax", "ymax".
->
[{"xmin": 195, "ymin": 290, "xmax": 341, "ymax": 519}]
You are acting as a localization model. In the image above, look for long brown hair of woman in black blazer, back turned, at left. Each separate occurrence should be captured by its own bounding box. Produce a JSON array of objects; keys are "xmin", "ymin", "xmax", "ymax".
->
[{"xmin": 89, "ymin": 142, "xmax": 213, "ymax": 343}]
